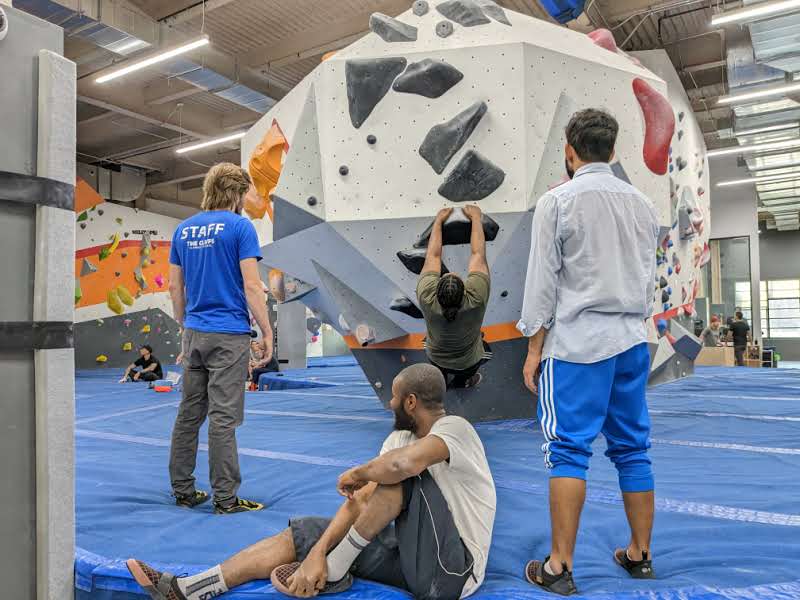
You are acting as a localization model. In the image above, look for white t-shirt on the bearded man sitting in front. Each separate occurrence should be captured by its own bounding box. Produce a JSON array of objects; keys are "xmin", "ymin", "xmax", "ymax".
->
[{"xmin": 381, "ymin": 416, "xmax": 497, "ymax": 598}]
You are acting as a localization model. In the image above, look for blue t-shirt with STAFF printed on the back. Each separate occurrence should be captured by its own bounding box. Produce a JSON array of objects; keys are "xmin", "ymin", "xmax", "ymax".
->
[{"xmin": 169, "ymin": 210, "xmax": 261, "ymax": 334}]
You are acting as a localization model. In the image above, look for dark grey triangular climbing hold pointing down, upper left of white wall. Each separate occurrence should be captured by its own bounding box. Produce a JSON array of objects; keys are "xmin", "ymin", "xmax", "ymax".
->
[{"xmin": 344, "ymin": 58, "xmax": 407, "ymax": 129}]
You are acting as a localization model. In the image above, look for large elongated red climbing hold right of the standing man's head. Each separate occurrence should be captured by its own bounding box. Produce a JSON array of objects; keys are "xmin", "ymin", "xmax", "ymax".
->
[{"xmin": 633, "ymin": 77, "xmax": 675, "ymax": 175}]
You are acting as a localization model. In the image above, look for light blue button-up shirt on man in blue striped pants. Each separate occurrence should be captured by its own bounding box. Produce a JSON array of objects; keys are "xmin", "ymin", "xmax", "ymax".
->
[{"xmin": 517, "ymin": 163, "xmax": 659, "ymax": 364}]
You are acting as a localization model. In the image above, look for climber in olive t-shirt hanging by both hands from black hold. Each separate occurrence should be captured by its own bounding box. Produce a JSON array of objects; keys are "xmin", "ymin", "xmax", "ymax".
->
[{"xmin": 417, "ymin": 206, "xmax": 492, "ymax": 388}]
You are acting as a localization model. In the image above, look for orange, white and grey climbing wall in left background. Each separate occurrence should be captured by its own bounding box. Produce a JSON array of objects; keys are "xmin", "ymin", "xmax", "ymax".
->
[{"xmin": 75, "ymin": 202, "xmax": 180, "ymax": 369}]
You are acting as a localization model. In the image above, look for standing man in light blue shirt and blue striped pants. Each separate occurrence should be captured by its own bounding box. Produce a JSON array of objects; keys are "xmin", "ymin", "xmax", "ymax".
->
[{"xmin": 517, "ymin": 109, "xmax": 659, "ymax": 595}]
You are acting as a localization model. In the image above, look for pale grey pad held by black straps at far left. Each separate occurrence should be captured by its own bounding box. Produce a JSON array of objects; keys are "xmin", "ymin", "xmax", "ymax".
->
[{"xmin": 33, "ymin": 50, "xmax": 76, "ymax": 600}]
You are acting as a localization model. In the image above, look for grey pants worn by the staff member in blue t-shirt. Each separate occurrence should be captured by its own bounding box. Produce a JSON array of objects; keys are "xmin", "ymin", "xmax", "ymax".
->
[{"xmin": 169, "ymin": 329, "xmax": 250, "ymax": 506}]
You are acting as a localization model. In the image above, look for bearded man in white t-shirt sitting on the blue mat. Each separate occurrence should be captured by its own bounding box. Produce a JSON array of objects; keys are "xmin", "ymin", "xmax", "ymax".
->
[{"xmin": 128, "ymin": 364, "xmax": 496, "ymax": 600}]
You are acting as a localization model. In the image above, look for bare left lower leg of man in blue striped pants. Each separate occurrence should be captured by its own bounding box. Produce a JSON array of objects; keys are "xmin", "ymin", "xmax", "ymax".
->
[{"xmin": 550, "ymin": 477, "xmax": 586, "ymax": 575}]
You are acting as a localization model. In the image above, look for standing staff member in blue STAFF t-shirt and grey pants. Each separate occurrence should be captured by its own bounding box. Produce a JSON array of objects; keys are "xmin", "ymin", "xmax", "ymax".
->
[{"xmin": 169, "ymin": 163, "xmax": 272, "ymax": 514}]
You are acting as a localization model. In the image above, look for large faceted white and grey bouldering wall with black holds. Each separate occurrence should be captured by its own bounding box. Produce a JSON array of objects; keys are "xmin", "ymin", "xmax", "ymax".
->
[{"xmin": 242, "ymin": 0, "xmax": 708, "ymax": 420}]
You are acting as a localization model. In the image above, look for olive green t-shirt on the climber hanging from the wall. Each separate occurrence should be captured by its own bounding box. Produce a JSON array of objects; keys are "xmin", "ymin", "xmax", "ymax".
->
[{"xmin": 417, "ymin": 271, "xmax": 490, "ymax": 371}]
